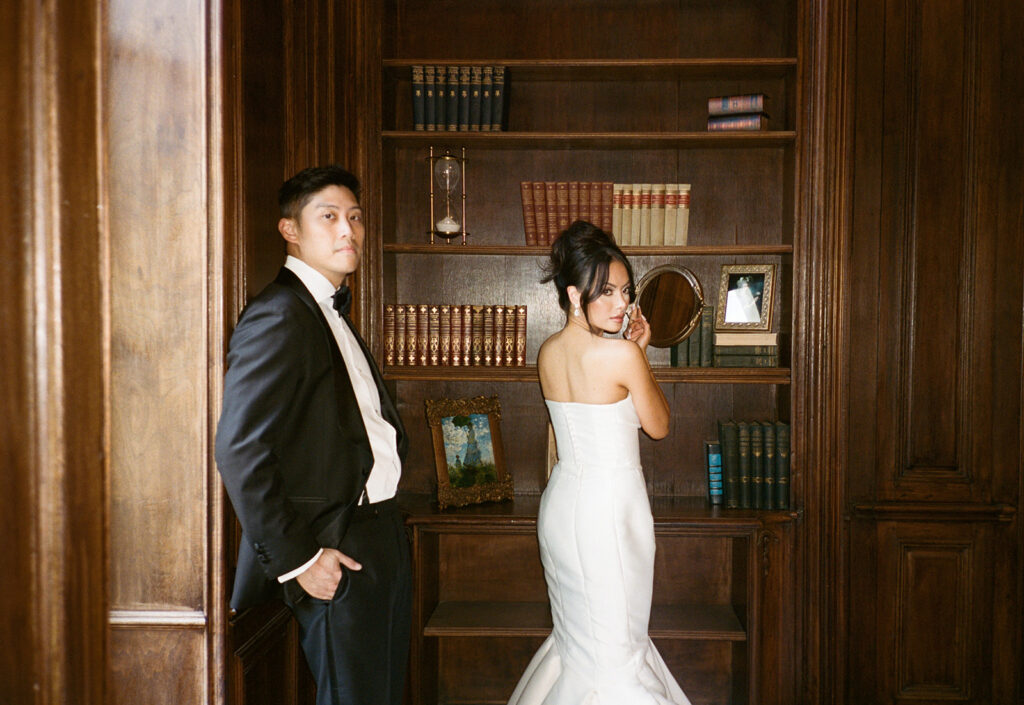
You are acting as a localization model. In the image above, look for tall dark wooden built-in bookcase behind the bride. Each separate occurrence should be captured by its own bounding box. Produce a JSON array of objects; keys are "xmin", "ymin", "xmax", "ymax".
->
[{"xmin": 368, "ymin": 0, "xmax": 804, "ymax": 705}]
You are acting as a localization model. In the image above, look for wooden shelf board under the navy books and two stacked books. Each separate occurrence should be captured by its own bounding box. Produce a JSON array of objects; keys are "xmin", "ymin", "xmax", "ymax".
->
[{"xmin": 381, "ymin": 130, "xmax": 797, "ymax": 150}]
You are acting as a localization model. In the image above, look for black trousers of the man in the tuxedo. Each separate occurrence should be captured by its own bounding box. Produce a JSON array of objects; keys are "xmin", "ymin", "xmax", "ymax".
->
[{"xmin": 286, "ymin": 499, "xmax": 412, "ymax": 705}]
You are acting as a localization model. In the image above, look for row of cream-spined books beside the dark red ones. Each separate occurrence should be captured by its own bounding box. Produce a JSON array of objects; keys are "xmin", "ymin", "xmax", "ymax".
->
[{"xmin": 611, "ymin": 183, "xmax": 690, "ymax": 247}]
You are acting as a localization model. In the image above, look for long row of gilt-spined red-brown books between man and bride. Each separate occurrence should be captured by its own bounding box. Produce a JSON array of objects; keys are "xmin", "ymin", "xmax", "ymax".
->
[{"xmin": 384, "ymin": 303, "xmax": 526, "ymax": 367}]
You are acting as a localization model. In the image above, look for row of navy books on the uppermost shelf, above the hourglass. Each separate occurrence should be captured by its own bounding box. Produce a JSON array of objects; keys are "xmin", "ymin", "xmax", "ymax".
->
[{"xmin": 413, "ymin": 66, "xmax": 506, "ymax": 132}]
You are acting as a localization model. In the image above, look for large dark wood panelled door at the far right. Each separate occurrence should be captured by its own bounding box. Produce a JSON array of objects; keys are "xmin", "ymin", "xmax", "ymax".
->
[{"xmin": 834, "ymin": 0, "xmax": 1024, "ymax": 704}]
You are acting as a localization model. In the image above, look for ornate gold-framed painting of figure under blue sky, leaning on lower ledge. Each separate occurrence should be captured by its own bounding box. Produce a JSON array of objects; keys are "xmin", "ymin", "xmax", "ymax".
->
[{"xmin": 426, "ymin": 397, "xmax": 514, "ymax": 509}]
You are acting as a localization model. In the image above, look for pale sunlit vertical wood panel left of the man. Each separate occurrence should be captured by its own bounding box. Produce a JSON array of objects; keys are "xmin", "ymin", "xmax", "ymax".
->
[{"xmin": 103, "ymin": 0, "xmax": 219, "ymax": 692}]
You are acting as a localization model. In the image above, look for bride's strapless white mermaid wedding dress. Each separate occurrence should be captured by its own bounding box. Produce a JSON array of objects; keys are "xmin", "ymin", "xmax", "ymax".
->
[{"xmin": 509, "ymin": 397, "xmax": 690, "ymax": 705}]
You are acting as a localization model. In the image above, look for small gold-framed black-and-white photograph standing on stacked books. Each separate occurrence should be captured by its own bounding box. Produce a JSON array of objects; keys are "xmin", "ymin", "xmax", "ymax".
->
[{"xmin": 715, "ymin": 264, "xmax": 775, "ymax": 331}]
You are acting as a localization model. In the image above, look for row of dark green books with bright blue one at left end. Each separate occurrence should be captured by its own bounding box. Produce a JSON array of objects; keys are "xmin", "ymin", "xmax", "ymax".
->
[{"xmin": 705, "ymin": 420, "xmax": 790, "ymax": 509}]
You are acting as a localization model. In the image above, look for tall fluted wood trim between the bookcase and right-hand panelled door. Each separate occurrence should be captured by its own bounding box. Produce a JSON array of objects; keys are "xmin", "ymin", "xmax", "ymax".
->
[{"xmin": 793, "ymin": 0, "xmax": 856, "ymax": 702}]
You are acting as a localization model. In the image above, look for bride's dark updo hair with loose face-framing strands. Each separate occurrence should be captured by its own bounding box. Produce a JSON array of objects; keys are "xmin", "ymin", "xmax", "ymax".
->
[{"xmin": 541, "ymin": 220, "xmax": 634, "ymax": 323}]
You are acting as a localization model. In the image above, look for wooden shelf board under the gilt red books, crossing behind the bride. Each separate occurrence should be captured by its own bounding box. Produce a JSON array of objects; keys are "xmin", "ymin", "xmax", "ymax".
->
[{"xmin": 384, "ymin": 365, "xmax": 791, "ymax": 384}]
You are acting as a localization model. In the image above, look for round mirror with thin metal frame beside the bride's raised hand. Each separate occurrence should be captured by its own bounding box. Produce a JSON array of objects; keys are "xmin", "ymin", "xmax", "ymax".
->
[{"xmin": 636, "ymin": 264, "xmax": 703, "ymax": 347}]
